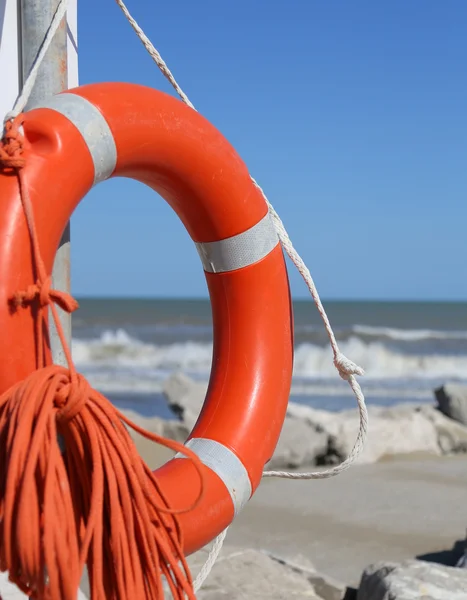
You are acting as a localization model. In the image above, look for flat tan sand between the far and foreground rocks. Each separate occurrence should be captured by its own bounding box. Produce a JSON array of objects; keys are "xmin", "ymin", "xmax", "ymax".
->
[{"xmin": 127, "ymin": 415, "xmax": 467, "ymax": 597}]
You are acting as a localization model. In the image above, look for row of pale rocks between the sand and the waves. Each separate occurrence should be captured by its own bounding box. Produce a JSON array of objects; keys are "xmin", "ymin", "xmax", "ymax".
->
[{"xmin": 158, "ymin": 374, "xmax": 467, "ymax": 469}]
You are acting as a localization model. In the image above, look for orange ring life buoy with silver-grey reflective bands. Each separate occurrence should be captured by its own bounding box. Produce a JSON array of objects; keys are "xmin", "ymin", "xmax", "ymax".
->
[{"xmin": 0, "ymin": 83, "xmax": 293, "ymax": 554}]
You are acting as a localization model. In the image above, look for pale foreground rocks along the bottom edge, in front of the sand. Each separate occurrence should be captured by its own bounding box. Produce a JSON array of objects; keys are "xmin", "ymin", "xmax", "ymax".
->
[{"xmin": 192, "ymin": 547, "xmax": 467, "ymax": 600}]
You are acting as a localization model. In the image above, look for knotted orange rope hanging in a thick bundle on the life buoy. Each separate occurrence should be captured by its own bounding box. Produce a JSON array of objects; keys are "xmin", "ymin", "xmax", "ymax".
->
[{"xmin": 0, "ymin": 116, "xmax": 203, "ymax": 600}]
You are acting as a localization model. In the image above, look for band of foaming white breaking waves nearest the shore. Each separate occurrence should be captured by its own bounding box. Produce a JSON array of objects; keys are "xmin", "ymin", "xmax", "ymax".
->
[{"xmin": 73, "ymin": 329, "xmax": 467, "ymax": 380}]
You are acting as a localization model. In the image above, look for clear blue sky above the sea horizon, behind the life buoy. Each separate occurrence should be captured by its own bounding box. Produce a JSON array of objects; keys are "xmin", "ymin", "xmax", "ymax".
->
[{"xmin": 72, "ymin": 0, "xmax": 467, "ymax": 300}]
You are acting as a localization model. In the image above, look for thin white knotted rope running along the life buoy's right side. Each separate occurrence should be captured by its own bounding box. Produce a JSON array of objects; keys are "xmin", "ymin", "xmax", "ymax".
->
[{"xmin": 115, "ymin": 0, "xmax": 368, "ymax": 591}]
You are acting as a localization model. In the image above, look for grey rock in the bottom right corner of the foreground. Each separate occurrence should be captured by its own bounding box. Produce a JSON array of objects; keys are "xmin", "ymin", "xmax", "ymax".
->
[{"xmin": 357, "ymin": 560, "xmax": 467, "ymax": 600}]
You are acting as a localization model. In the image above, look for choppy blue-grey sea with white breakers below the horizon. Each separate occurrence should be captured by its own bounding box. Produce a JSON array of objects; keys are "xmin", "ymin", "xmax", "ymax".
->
[{"xmin": 72, "ymin": 298, "xmax": 467, "ymax": 418}]
